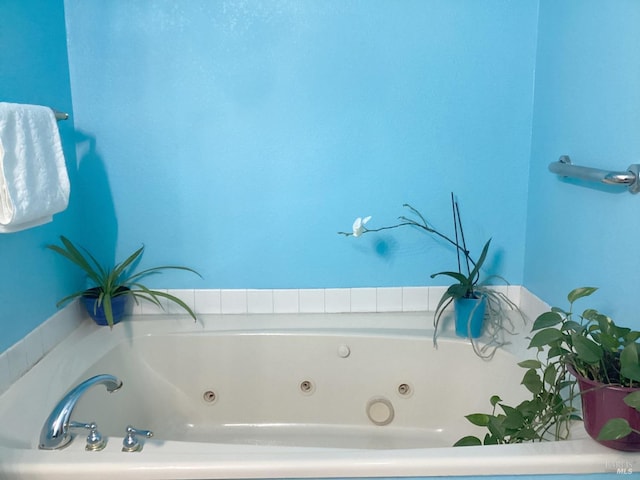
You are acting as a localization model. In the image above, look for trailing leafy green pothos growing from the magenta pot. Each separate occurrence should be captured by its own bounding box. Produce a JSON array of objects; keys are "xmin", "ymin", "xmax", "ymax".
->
[{"xmin": 455, "ymin": 287, "xmax": 640, "ymax": 446}]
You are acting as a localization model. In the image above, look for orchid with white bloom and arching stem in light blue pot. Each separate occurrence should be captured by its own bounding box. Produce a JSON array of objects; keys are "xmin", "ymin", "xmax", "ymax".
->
[{"xmin": 338, "ymin": 193, "xmax": 520, "ymax": 358}]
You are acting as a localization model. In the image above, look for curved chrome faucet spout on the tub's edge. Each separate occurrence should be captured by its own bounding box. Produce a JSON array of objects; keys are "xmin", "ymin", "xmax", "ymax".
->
[{"xmin": 39, "ymin": 374, "xmax": 122, "ymax": 450}]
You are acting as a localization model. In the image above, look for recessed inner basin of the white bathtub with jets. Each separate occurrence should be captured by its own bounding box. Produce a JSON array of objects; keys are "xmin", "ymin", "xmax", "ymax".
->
[{"xmin": 70, "ymin": 330, "xmax": 526, "ymax": 449}]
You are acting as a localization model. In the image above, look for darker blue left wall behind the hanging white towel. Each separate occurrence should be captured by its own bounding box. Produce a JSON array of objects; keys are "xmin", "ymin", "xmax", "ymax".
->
[{"xmin": 0, "ymin": 0, "xmax": 79, "ymax": 351}]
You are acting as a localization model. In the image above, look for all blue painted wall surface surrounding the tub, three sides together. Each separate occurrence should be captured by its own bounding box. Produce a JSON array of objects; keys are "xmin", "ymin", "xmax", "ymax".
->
[{"xmin": 0, "ymin": 0, "xmax": 640, "ymax": 348}]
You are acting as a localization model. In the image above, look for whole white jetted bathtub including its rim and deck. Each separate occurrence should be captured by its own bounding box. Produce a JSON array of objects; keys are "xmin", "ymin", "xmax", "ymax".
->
[{"xmin": 0, "ymin": 313, "xmax": 640, "ymax": 480}]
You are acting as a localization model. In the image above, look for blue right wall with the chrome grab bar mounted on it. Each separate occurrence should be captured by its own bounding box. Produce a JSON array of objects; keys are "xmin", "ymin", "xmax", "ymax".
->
[{"xmin": 524, "ymin": 0, "xmax": 640, "ymax": 328}]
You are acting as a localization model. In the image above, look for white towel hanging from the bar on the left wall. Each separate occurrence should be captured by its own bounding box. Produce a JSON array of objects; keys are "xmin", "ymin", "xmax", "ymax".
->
[{"xmin": 0, "ymin": 102, "xmax": 70, "ymax": 233}]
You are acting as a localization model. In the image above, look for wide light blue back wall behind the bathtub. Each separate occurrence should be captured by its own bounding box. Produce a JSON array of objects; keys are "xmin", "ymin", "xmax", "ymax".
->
[{"xmin": 65, "ymin": 0, "xmax": 537, "ymax": 288}]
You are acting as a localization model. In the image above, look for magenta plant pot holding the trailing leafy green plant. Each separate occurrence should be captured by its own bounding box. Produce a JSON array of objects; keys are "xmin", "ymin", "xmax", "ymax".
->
[{"xmin": 569, "ymin": 368, "xmax": 640, "ymax": 452}]
